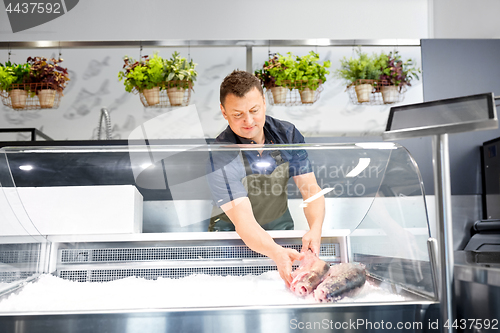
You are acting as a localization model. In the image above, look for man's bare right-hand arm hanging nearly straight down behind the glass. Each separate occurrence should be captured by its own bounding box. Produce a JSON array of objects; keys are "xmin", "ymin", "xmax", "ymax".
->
[{"xmin": 293, "ymin": 172, "xmax": 325, "ymax": 255}]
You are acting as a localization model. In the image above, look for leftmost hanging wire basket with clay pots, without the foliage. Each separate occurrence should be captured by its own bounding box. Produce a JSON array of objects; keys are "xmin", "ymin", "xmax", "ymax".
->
[{"xmin": 0, "ymin": 83, "xmax": 62, "ymax": 111}]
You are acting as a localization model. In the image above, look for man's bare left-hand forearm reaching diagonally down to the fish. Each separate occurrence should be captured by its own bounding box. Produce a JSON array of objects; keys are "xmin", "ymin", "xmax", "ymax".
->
[{"xmin": 221, "ymin": 197, "xmax": 304, "ymax": 287}]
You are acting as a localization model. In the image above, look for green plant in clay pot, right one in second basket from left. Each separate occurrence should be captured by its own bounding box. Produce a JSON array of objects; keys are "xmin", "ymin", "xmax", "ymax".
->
[{"xmin": 164, "ymin": 51, "xmax": 198, "ymax": 106}]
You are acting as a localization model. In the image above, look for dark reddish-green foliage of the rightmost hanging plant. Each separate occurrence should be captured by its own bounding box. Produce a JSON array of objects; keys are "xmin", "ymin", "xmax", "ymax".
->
[{"xmin": 380, "ymin": 51, "xmax": 421, "ymax": 86}]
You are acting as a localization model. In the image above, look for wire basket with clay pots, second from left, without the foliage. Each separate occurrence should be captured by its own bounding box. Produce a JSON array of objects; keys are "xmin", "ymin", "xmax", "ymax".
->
[{"xmin": 134, "ymin": 80, "xmax": 193, "ymax": 108}]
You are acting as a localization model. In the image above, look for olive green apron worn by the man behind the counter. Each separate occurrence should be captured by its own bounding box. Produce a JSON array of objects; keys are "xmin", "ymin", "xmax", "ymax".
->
[{"xmin": 208, "ymin": 151, "xmax": 293, "ymax": 231}]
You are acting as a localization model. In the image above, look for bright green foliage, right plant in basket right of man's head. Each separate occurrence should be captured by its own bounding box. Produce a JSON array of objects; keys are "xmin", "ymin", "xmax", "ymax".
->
[{"xmin": 295, "ymin": 51, "xmax": 331, "ymax": 90}]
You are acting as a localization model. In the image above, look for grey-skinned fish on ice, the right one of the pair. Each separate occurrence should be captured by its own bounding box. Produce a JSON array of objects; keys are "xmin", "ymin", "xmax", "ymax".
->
[{"xmin": 314, "ymin": 263, "xmax": 366, "ymax": 303}]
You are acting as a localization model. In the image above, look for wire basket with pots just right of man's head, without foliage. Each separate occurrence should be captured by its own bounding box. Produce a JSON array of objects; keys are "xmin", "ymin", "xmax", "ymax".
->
[{"xmin": 266, "ymin": 80, "xmax": 323, "ymax": 106}]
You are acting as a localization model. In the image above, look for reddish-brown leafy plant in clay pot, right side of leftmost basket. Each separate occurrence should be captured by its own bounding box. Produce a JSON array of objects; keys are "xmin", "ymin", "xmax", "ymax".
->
[{"xmin": 28, "ymin": 57, "xmax": 69, "ymax": 109}]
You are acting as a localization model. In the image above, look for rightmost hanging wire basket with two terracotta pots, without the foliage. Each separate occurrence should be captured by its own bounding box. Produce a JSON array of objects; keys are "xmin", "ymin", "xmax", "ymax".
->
[{"xmin": 346, "ymin": 80, "xmax": 407, "ymax": 105}]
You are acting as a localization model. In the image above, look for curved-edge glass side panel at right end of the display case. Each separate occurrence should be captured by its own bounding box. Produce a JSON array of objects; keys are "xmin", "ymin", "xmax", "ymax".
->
[{"xmin": 350, "ymin": 144, "xmax": 434, "ymax": 296}]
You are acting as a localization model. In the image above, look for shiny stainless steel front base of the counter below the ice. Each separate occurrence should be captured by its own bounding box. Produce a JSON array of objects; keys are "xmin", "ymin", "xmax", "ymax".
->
[{"xmin": 0, "ymin": 302, "xmax": 438, "ymax": 333}]
